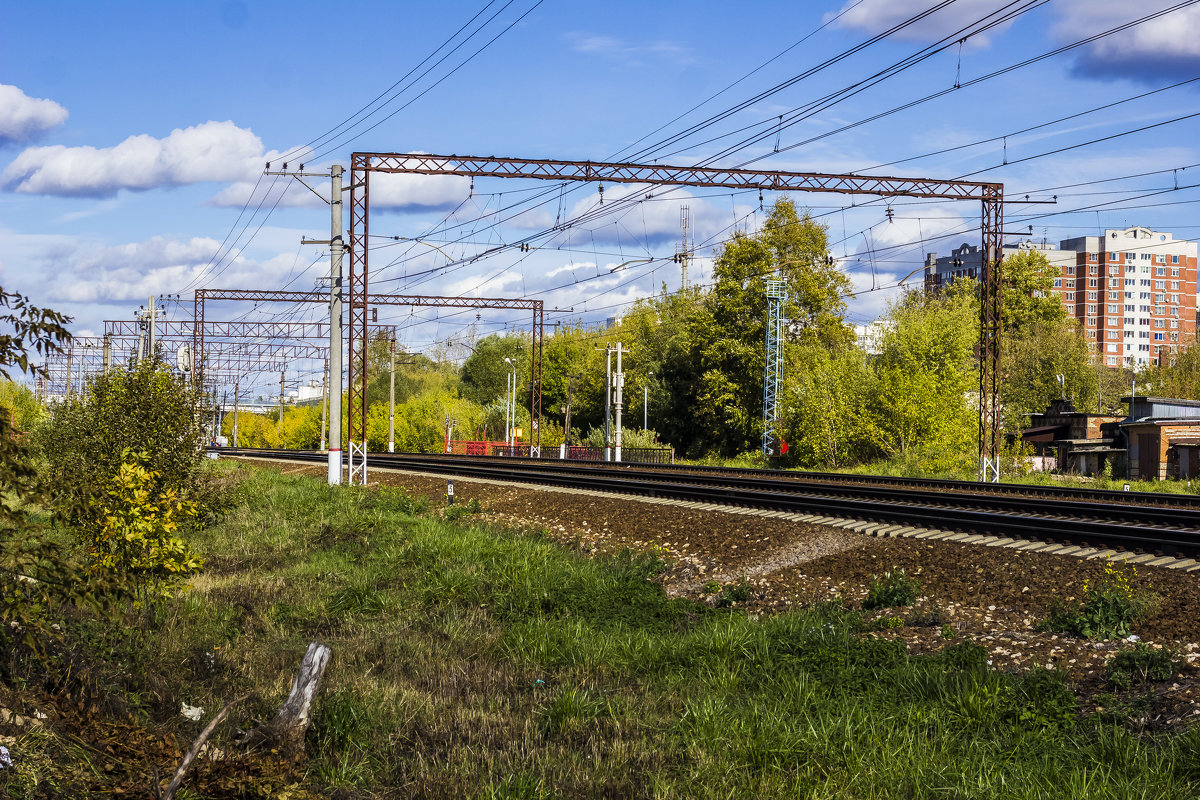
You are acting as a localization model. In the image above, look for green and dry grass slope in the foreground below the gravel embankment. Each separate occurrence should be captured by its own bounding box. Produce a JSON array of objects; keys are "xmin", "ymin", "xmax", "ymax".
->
[{"xmin": 54, "ymin": 462, "xmax": 1200, "ymax": 800}]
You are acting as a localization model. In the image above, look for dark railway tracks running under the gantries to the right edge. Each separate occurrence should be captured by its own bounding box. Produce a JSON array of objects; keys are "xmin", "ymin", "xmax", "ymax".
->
[{"xmin": 222, "ymin": 449, "xmax": 1200, "ymax": 558}]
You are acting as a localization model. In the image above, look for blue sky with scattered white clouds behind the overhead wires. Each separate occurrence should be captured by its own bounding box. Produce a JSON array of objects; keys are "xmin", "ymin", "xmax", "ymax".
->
[{"xmin": 0, "ymin": 0, "xmax": 1200, "ymax": 393}]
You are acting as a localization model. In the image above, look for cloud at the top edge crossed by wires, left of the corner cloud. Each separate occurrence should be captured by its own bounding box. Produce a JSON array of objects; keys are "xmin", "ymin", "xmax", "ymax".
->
[{"xmin": 824, "ymin": 0, "xmax": 1012, "ymax": 47}]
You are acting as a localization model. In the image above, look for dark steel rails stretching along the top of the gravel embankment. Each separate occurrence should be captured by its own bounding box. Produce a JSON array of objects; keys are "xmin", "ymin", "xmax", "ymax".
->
[{"xmin": 223, "ymin": 449, "xmax": 1200, "ymax": 557}]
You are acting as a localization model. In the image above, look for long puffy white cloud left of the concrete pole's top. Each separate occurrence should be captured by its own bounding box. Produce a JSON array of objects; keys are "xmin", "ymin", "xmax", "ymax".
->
[{"xmin": 0, "ymin": 121, "xmax": 302, "ymax": 197}]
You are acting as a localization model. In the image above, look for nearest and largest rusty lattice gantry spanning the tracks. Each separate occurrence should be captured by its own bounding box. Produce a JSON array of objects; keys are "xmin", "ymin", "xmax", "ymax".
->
[{"xmin": 349, "ymin": 152, "xmax": 1004, "ymax": 481}]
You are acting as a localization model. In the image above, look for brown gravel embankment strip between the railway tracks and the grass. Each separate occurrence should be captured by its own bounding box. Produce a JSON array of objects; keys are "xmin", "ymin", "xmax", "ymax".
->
[{"xmin": 238, "ymin": 462, "xmax": 1200, "ymax": 729}]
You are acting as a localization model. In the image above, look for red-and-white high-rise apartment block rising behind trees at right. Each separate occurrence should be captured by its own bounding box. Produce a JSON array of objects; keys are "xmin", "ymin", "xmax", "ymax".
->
[{"xmin": 925, "ymin": 227, "xmax": 1196, "ymax": 367}]
